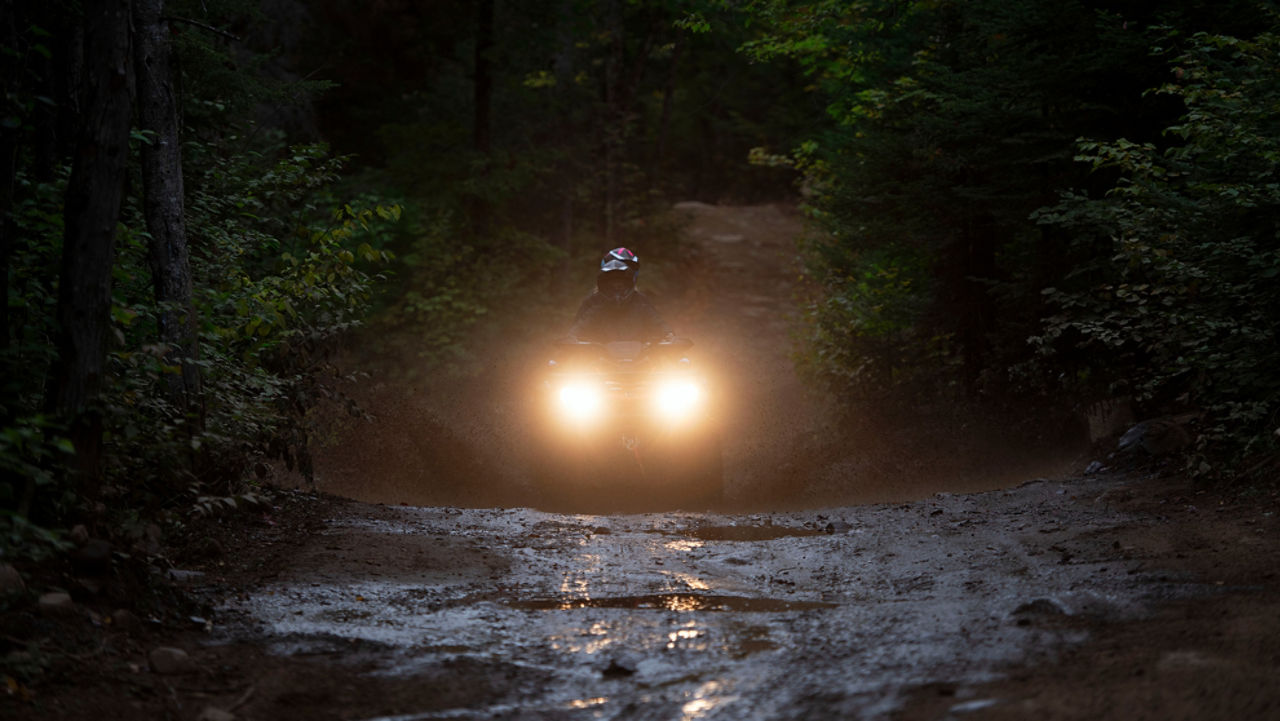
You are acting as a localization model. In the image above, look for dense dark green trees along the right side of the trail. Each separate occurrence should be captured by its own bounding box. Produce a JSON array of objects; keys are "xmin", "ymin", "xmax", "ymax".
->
[{"xmin": 744, "ymin": 0, "xmax": 1280, "ymax": 470}]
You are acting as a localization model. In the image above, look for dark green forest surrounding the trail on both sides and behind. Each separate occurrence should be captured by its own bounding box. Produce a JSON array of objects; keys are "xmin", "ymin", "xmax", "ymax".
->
[{"xmin": 0, "ymin": 0, "xmax": 1280, "ymax": 558}]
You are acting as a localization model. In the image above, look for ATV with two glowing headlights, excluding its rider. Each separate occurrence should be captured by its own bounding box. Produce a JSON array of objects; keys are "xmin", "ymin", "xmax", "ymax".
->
[{"xmin": 534, "ymin": 338, "xmax": 723, "ymax": 512}]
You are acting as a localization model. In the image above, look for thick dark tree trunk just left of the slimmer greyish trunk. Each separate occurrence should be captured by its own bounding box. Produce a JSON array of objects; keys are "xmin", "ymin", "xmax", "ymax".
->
[{"xmin": 46, "ymin": 0, "xmax": 133, "ymax": 498}]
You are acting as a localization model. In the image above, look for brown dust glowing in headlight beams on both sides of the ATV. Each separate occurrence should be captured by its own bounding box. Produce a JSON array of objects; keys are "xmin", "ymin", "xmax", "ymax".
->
[{"xmin": 304, "ymin": 202, "xmax": 1082, "ymax": 511}]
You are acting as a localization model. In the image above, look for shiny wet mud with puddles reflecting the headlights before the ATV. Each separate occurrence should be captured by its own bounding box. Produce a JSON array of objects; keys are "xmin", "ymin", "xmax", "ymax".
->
[{"xmin": 199, "ymin": 479, "xmax": 1228, "ymax": 721}]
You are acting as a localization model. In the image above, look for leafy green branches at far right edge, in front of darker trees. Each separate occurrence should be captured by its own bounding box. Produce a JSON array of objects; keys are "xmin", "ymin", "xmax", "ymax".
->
[{"xmin": 1033, "ymin": 33, "xmax": 1280, "ymax": 471}]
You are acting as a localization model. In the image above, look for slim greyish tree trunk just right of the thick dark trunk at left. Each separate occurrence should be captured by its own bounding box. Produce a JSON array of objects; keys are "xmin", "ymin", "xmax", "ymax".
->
[{"xmin": 133, "ymin": 0, "xmax": 204, "ymax": 428}]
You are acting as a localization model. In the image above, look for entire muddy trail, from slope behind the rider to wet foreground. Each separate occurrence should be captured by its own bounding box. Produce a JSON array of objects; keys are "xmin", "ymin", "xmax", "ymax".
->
[{"xmin": 12, "ymin": 204, "xmax": 1280, "ymax": 721}]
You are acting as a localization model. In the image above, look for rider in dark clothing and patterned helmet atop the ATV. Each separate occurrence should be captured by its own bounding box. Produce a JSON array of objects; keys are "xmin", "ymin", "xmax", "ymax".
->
[{"xmin": 568, "ymin": 247, "xmax": 675, "ymax": 343}]
